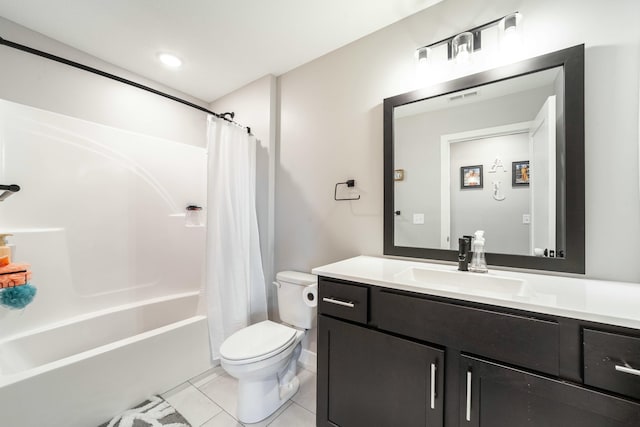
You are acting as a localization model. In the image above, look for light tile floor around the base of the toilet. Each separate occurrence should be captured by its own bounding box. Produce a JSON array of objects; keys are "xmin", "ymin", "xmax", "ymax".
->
[{"xmin": 162, "ymin": 366, "xmax": 316, "ymax": 427}]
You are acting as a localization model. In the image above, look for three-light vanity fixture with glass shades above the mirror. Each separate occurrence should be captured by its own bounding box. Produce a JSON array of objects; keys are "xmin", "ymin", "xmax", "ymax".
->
[{"xmin": 416, "ymin": 12, "xmax": 522, "ymax": 69}]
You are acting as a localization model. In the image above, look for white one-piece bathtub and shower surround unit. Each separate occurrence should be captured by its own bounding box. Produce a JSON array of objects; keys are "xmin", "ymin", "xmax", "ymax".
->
[{"xmin": 0, "ymin": 100, "xmax": 211, "ymax": 427}]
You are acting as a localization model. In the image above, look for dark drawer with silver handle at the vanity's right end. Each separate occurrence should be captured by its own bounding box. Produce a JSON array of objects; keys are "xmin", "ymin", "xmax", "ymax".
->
[{"xmin": 584, "ymin": 329, "xmax": 640, "ymax": 399}]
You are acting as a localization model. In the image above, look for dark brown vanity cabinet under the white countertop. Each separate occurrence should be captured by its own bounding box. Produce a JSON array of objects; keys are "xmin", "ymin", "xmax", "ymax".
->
[{"xmin": 317, "ymin": 277, "xmax": 640, "ymax": 427}]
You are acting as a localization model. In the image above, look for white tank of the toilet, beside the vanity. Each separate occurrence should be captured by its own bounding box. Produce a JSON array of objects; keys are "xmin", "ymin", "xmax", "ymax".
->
[{"xmin": 276, "ymin": 271, "xmax": 318, "ymax": 329}]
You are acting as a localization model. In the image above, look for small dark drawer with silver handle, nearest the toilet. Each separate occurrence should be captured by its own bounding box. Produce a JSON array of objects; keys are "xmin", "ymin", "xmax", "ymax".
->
[{"xmin": 318, "ymin": 278, "xmax": 369, "ymax": 323}]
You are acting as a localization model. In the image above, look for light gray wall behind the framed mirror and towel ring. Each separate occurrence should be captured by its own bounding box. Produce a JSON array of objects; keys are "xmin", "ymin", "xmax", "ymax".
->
[{"xmin": 268, "ymin": 0, "xmax": 640, "ymax": 281}]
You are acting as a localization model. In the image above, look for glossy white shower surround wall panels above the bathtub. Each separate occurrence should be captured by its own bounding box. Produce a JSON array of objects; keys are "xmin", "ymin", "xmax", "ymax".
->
[{"xmin": 0, "ymin": 101, "xmax": 206, "ymax": 339}]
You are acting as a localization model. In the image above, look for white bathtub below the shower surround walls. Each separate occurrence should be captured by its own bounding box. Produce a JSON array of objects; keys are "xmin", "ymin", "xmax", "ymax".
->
[{"xmin": 0, "ymin": 292, "xmax": 211, "ymax": 427}]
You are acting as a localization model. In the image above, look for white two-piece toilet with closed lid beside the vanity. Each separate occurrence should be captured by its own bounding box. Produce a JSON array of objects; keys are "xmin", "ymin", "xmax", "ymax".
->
[{"xmin": 220, "ymin": 271, "xmax": 317, "ymax": 423}]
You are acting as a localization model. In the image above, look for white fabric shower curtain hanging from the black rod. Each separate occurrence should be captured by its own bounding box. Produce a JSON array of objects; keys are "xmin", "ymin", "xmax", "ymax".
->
[{"xmin": 206, "ymin": 116, "xmax": 267, "ymax": 360}]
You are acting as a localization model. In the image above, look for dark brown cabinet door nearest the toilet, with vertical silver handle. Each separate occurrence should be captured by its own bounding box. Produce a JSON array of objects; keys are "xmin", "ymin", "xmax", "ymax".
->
[{"xmin": 318, "ymin": 315, "xmax": 444, "ymax": 427}]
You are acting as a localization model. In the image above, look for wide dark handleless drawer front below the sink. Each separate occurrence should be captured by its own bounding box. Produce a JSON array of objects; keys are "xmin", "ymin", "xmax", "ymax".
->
[{"xmin": 375, "ymin": 291, "xmax": 560, "ymax": 376}]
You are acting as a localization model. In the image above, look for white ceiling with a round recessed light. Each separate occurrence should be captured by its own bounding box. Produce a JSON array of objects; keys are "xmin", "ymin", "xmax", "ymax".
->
[{"xmin": 0, "ymin": 0, "xmax": 442, "ymax": 102}]
